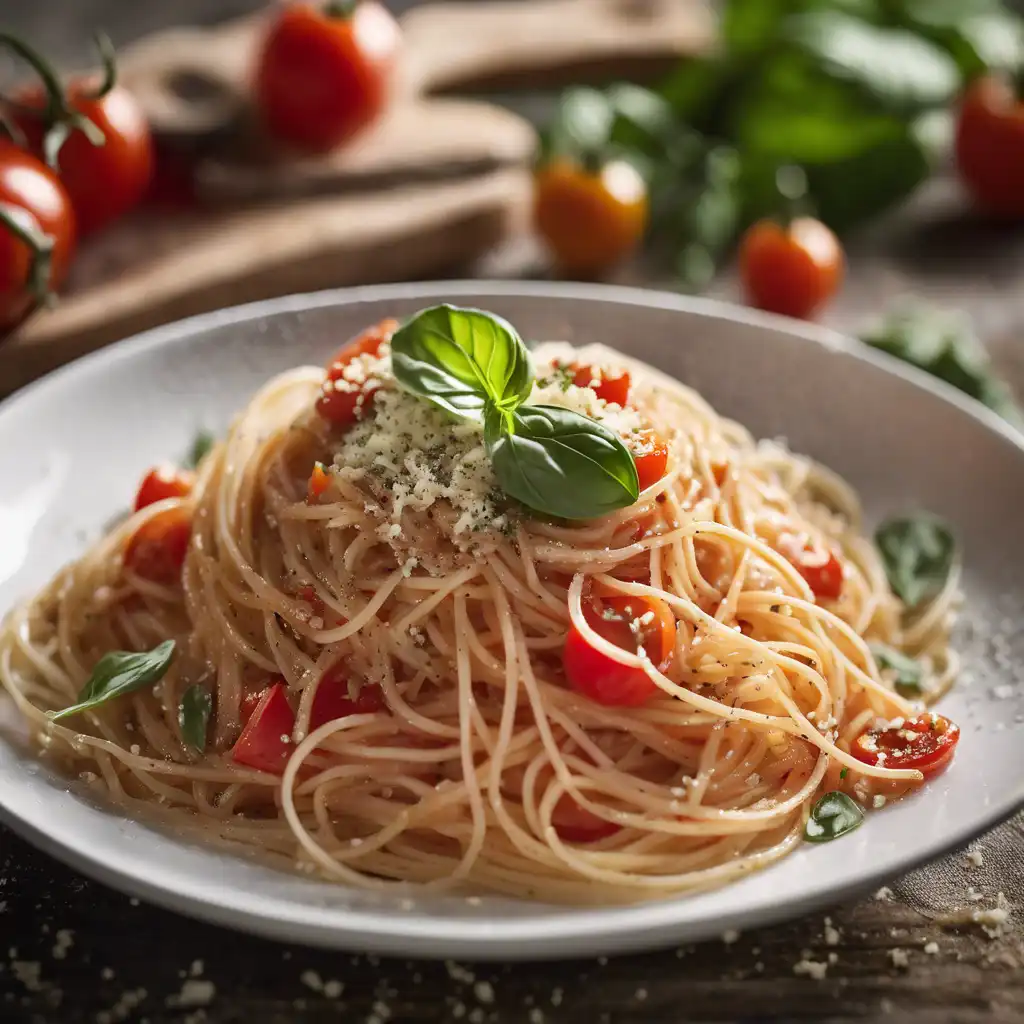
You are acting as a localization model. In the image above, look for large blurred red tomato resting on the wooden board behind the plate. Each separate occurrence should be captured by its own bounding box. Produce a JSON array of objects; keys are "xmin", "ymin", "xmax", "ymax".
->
[{"xmin": 256, "ymin": 0, "xmax": 401, "ymax": 153}]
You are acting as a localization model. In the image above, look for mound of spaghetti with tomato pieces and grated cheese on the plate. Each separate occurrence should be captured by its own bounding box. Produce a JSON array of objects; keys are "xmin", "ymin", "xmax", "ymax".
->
[{"xmin": 0, "ymin": 310, "xmax": 956, "ymax": 903}]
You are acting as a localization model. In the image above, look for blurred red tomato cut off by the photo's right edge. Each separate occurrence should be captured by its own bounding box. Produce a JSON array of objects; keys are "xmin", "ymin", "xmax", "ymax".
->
[{"xmin": 955, "ymin": 75, "xmax": 1024, "ymax": 218}]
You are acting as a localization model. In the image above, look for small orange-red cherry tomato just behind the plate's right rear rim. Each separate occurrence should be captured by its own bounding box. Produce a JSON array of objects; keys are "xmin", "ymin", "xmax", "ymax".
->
[{"xmin": 739, "ymin": 217, "xmax": 844, "ymax": 318}]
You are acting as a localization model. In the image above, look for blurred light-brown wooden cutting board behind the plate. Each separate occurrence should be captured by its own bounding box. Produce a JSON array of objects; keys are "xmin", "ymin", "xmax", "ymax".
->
[{"xmin": 0, "ymin": 0, "xmax": 712, "ymax": 394}]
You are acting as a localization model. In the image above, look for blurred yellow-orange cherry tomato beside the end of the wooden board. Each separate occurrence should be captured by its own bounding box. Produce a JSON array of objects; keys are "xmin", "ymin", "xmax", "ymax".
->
[{"xmin": 534, "ymin": 160, "xmax": 647, "ymax": 274}]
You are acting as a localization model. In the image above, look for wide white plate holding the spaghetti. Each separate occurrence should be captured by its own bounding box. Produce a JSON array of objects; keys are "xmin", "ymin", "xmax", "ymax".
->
[{"xmin": 0, "ymin": 283, "xmax": 1024, "ymax": 959}]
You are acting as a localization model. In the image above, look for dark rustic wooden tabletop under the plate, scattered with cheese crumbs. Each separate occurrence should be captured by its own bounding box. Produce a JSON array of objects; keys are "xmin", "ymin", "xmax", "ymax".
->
[{"xmin": 0, "ymin": 0, "xmax": 1024, "ymax": 1024}]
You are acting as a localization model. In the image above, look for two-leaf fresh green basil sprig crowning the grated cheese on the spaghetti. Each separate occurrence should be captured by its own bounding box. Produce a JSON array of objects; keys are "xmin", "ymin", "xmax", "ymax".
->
[{"xmin": 391, "ymin": 305, "xmax": 640, "ymax": 519}]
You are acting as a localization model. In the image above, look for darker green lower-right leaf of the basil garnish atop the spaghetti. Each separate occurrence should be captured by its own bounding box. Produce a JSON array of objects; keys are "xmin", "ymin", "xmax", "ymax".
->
[{"xmin": 485, "ymin": 406, "xmax": 640, "ymax": 519}]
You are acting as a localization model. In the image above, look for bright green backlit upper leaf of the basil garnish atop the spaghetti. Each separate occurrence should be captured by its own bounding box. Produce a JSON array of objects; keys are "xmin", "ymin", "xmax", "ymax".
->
[{"xmin": 391, "ymin": 304, "xmax": 534, "ymax": 420}]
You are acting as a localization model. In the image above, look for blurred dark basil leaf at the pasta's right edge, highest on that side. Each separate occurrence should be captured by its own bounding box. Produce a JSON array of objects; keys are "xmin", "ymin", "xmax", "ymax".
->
[{"xmin": 874, "ymin": 514, "xmax": 956, "ymax": 608}]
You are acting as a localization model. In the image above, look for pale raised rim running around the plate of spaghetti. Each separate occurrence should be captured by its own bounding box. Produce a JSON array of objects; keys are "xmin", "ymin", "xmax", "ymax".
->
[{"xmin": 0, "ymin": 280, "xmax": 1024, "ymax": 959}]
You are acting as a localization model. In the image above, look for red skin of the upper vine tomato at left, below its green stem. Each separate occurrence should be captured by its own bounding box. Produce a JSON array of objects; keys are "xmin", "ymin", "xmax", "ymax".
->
[{"xmin": 16, "ymin": 80, "xmax": 154, "ymax": 234}]
